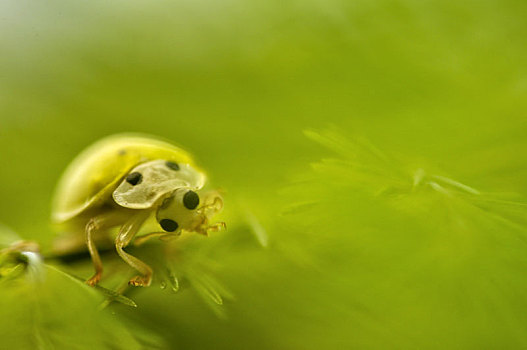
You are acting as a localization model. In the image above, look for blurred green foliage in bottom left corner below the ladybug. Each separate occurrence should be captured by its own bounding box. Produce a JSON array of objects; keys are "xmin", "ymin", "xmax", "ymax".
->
[{"xmin": 0, "ymin": 265, "xmax": 161, "ymax": 350}]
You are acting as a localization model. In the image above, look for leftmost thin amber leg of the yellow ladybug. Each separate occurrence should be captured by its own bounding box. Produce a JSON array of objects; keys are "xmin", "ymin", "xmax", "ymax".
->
[{"xmin": 86, "ymin": 212, "xmax": 129, "ymax": 286}]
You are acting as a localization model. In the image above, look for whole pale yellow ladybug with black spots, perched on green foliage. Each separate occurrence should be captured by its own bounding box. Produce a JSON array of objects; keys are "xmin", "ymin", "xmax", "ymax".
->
[{"xmin": 52, "ymin": 134, "xmax": 225, "ymax": 286}]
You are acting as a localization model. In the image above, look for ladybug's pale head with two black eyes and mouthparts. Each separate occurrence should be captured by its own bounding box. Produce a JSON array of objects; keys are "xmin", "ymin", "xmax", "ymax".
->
[{"xmin": 156, "ymin": 188, "xmax": 225, "ymax": 235}]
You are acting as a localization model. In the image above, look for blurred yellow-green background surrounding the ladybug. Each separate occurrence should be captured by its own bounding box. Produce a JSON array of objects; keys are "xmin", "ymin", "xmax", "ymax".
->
[{"xmin": 0, "ymin": 0, "xmax": 527, "ymax": 349}]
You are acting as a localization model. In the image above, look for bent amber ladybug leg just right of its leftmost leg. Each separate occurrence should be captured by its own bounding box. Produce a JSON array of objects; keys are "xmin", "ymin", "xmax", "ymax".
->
[{"xmin": 115, "ymin": 211, "xmax": 152, "ymax": 287}]
